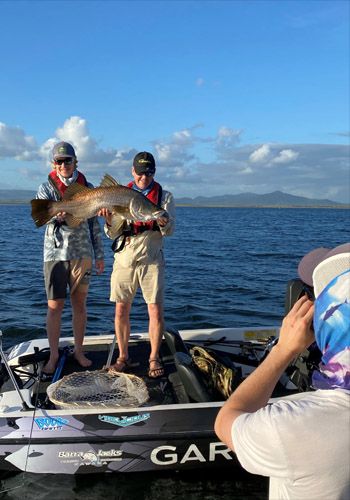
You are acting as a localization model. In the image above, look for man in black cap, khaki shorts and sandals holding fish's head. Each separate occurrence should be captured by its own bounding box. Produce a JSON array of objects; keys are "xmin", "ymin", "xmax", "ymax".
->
[{"xmin": 99, "ymin": 151, "xmax": 175, "ymax": 378}]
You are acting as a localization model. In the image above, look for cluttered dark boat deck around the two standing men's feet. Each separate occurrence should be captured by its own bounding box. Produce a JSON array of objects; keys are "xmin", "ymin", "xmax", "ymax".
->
[{"xmin": 3, "ymin": 324, "xmax": 308, "ymax": 409}]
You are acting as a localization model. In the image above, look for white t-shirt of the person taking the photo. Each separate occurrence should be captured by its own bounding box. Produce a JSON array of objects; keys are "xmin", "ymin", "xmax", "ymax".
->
[{"xmin": 232, "ymin": 389, "xmax": 350, "ymax": 500}]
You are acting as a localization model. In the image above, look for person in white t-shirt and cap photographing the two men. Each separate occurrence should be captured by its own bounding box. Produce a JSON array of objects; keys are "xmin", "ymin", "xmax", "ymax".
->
[{"xmin": 215, "ymin": 243, "xmax": 350, "ymax": 500}]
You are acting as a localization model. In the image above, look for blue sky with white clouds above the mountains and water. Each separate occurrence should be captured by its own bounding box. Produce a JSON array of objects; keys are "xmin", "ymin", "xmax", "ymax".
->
[{"xmin": 0, "ymin": 0, "xmax": 350, "ymax": 202}]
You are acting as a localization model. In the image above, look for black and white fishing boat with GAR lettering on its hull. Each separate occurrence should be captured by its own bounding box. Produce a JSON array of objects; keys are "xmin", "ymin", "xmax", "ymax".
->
[{"xmin": 0, "ymin": 280, "xmax": 316, "ymax": 474}]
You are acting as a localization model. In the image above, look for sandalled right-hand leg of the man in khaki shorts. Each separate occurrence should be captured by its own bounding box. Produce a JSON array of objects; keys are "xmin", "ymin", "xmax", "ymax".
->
[{"xmin": 148, "ymin": 304, "xmax": 164, "ymax": 377}]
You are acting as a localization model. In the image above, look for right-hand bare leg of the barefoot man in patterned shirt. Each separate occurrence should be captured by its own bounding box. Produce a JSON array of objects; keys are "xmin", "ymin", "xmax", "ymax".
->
[{"xmin": 71, "ymin": 289, "xmax": 92, "ymax": 368}]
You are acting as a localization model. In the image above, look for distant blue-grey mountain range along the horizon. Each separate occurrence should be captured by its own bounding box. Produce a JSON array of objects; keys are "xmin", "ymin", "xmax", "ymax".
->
[{"xmin": 0, "ymin": 189, "xmax": 350, "ymax": 208}]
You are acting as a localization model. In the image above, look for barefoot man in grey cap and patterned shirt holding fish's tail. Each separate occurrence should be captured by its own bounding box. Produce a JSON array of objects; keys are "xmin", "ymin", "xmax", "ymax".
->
[{"xmin": 36, "ymin": 142, "xmax": 104, "ymax": 375}]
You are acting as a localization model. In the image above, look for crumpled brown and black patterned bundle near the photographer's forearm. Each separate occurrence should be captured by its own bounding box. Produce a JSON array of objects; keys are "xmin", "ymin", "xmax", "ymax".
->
[{"xmin": 191, "ymin": 346, "xmax": 242, "ymax": 399}]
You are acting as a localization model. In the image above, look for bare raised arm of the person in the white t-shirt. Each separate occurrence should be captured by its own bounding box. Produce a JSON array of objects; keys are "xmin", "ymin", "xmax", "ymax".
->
[{"xmin": 215, "ymin": 296, "xmax": 314, "ymax": 450}]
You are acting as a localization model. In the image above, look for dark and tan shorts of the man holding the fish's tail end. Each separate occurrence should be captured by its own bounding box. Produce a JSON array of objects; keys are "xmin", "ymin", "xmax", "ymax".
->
[{"xmin": 44, "ymin": 258, "xmax": 92, "ymax": 300}]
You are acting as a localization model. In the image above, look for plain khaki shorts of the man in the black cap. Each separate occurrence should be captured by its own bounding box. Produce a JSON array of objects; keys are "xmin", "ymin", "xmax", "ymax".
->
[{"xmin": 110, "ymin": 262, "xmax": 164, "ymax": 304}]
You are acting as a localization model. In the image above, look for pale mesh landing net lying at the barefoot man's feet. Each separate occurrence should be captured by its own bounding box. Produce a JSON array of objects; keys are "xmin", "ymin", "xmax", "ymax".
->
[{"xmin": 47, "ymin": 370, "xmax": 149, "ymax": 409}]
